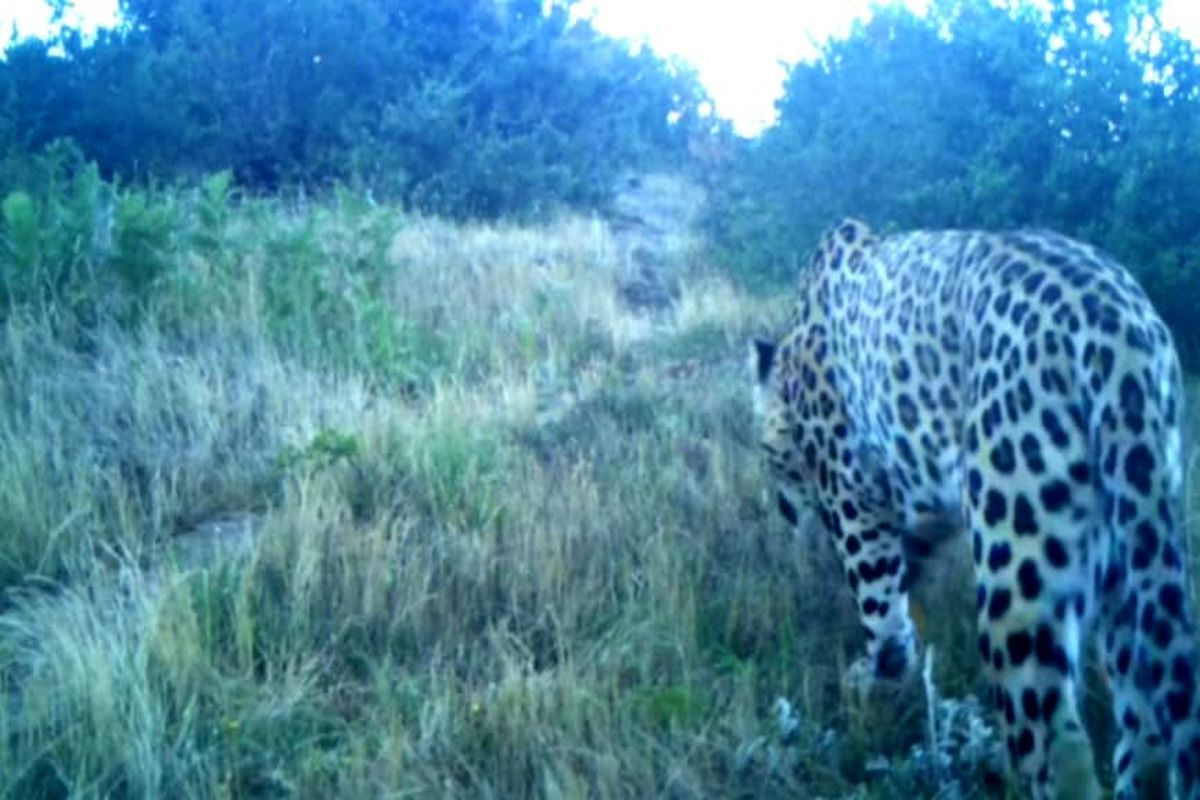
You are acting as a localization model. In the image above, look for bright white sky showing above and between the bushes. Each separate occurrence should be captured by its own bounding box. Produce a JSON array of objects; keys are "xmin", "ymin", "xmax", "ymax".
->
[{"xmin": 7, "ymin": 0, "xmax": 1200, "ymax": 134}]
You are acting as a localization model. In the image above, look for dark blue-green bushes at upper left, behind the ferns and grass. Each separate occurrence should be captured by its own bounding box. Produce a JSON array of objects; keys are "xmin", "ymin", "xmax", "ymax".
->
[{"xmin": 0, "ymin": 0, "xmax": 703, "ymax": 217}]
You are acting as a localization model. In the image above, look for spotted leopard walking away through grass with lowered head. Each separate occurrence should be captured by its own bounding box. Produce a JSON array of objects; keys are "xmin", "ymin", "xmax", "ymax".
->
[{"xmin": 750, "ymin": 218, "xmax": 1200, "ymax": 800}]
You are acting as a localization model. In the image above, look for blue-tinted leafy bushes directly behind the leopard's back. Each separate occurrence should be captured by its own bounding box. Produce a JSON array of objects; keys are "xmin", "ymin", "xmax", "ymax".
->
[{"xmin": 709, "ymin": 0, "xmax": 1200, "ymax": 355}]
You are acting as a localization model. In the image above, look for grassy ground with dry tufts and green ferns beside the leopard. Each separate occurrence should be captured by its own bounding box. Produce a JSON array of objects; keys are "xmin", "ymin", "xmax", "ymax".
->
[{"xmin": 0, "ymin": 187, "xmax": 1200, "ymax": 798}]
